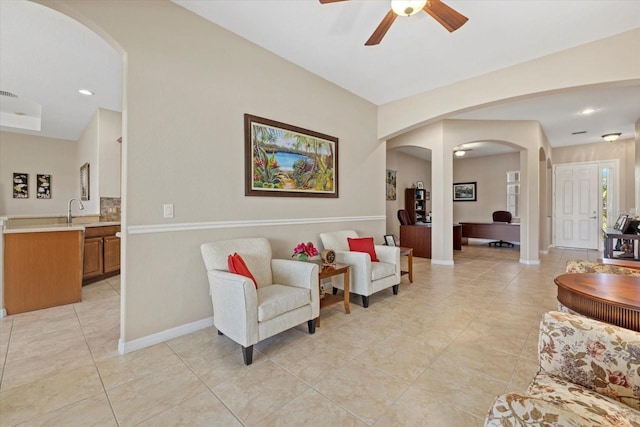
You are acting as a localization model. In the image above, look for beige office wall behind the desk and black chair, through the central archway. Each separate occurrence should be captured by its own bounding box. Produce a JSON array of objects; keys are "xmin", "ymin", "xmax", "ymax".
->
[{"xmin": 453, "ymin": 152, "xmax": 520, "ymax": 223}]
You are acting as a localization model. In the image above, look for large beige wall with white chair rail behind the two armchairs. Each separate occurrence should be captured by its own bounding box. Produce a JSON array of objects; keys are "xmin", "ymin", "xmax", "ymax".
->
[{"xmin": 46, "ymin": 1, "xmax": 385, "ymax": 347}]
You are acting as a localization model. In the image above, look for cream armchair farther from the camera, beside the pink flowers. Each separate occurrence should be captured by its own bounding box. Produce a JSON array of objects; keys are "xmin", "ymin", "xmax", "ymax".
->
[{"xmin": 320, "ymin": 230, "xmax": 400, "ymax": 308}]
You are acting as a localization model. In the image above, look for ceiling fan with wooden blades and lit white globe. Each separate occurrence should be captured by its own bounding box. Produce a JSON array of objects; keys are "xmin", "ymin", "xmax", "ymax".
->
[{"xmin": 320, "ymin": 0, "xmax": 469, "ymax": 46}]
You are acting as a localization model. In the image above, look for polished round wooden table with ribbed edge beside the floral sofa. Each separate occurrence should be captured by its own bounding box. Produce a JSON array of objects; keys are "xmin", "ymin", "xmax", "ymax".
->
[{"xmin": 554, "ymin": 273, "xmax": 640, "ymax": 332}]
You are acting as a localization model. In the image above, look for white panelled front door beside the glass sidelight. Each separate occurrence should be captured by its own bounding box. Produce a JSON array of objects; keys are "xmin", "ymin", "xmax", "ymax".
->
[{"xmin": 553, "ymin": 163, "xmax": 600, "ymax": 249}]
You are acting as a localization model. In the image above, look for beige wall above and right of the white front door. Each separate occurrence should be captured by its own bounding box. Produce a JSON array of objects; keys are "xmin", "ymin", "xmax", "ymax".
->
[{"xmin": 552, "ymin": 139, "xmax": 636, "ymax": 212}]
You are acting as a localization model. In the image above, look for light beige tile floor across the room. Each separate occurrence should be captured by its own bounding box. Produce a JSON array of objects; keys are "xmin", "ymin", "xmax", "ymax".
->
[{"xmin": 0, "ymin": 245, "xmax": 601, "ymax": 427}]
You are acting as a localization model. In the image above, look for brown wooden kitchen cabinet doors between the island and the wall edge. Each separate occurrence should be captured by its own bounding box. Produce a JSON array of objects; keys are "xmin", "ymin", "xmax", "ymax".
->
[{"xmin": 82, "ymin": 225, "xmax": 120, "ymax": 285}]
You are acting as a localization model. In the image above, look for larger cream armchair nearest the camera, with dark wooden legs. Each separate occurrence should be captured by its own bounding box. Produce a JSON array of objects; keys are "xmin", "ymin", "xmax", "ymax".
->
[{"xmin": 200, "ymin": 238, "xmax": 320, "ymax": 365}]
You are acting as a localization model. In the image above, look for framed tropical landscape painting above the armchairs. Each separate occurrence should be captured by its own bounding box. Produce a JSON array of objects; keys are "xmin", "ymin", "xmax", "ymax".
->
[{"xmin": 244, "ymin": 114, "xmax": 338, "ymax": 198}]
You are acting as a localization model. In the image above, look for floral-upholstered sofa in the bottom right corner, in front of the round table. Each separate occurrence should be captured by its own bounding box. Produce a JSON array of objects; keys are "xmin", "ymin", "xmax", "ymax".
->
[{"xmin": 484, "ymin": 311, "xmax": 640, "ymax": 427}]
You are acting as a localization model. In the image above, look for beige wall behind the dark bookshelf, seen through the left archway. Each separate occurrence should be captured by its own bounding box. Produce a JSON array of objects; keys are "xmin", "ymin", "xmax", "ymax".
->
[{"xmin": 386, "ymin": 149, "xmax": 431, "ymax": 236}]
